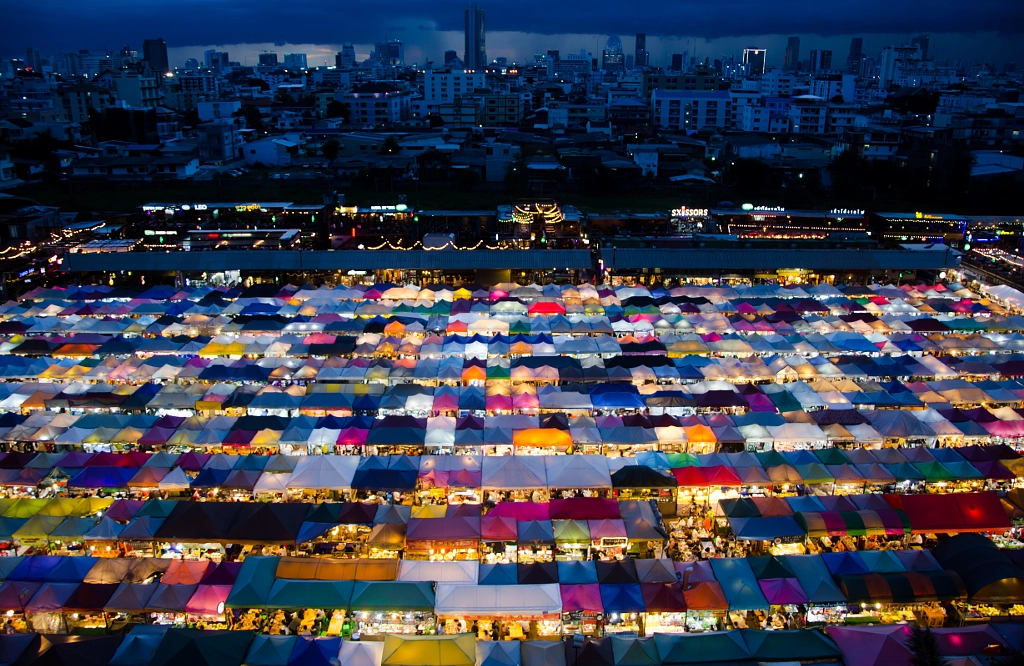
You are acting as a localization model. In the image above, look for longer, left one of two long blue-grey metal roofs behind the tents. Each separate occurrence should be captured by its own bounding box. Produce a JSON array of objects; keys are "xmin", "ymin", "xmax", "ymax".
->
[{"xmin": 63, "ymin": 250, "xmax": 593, "ymax": 273}]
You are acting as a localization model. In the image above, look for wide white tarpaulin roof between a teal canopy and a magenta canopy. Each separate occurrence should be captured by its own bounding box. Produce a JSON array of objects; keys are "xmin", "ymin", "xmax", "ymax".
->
[{"xmin": 434, "ymin": 583, "xmax": 562, "ymax": 617}]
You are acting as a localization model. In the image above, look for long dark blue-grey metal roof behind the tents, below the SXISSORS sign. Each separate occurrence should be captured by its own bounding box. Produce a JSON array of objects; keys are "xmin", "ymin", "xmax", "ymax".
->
[{"xmin": 601, "ymin": 247, "xmax": 961, "ymax": 270}]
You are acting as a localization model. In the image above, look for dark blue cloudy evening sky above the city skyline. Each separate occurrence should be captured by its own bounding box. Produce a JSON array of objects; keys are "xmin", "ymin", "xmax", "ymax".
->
[{"xmin": 0, "ymin": 0, "xmax": 1024, "ymax": 66}]
